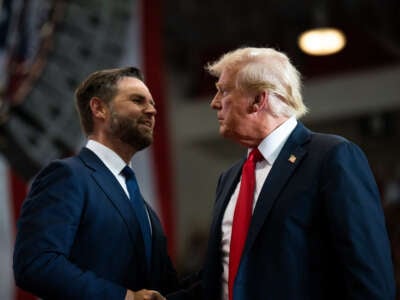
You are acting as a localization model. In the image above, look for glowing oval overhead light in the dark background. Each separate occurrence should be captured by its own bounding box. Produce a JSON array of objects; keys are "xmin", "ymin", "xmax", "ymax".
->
[{"xmin": 298, "ymin": 27, "xmax": 346, "ymax": 55}]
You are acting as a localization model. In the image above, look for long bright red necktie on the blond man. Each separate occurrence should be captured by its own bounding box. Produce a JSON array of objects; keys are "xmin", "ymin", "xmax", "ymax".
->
[{"xmin": 228, "ymin": 148, "xmax": 264, "ymax": 300}]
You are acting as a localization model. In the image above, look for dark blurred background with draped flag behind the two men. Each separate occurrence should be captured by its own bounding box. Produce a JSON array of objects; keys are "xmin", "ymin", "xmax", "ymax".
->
[{"xmin": 0, "ymin": 0, "xmax": 400, "ymax": 300}]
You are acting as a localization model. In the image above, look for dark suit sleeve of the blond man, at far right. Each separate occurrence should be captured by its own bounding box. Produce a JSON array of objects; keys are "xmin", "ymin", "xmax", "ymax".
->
[{"xmin": 322, "ymin": 141, "xmax": 395, "ymax": 300}]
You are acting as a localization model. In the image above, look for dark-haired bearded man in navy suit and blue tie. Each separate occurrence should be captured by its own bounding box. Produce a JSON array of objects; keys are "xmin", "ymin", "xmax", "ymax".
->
[{"xmin": 14, "ymin": 67, "xmax": 173, "ymax": 300}]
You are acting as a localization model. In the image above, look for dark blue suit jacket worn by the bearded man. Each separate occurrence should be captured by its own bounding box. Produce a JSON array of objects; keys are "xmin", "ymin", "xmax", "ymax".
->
[{"xmin": 14, "ymin": 148, "xmax": 177, "ymax": 299}]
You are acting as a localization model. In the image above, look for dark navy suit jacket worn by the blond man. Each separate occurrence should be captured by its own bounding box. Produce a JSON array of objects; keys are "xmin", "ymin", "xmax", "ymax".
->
[{"xmin": 203, "ymin": 123, "xmax": 395, "ymax": 300}]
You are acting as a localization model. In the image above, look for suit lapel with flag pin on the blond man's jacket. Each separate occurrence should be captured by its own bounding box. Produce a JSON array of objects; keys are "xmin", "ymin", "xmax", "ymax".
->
[{"xmin": 243, "ymin": 123, "xmax": 310, "ymax": 255}]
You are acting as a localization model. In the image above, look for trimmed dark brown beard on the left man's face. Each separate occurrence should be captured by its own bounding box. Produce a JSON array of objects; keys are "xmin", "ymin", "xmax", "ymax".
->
[{"xmin": 110, "ymin": 111, "xmax": 153, "ymax": 151}]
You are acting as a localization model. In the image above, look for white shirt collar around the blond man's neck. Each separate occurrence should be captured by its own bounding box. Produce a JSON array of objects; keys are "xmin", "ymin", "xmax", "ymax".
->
[{"xmin": 253, "ymin": 116, "xmax": 297, "ymax": 165}]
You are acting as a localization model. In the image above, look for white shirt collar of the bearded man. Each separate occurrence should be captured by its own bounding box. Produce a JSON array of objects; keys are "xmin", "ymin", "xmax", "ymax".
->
[{"xmin": 86, "ymin": 140, "xmax": 130, "ymax": 175}]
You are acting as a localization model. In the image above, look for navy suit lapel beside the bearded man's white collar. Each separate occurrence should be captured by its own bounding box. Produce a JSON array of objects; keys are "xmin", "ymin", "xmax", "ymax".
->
[{"xmin": 79, "ymin": 148, "xmax": 140, "ymax": 243}]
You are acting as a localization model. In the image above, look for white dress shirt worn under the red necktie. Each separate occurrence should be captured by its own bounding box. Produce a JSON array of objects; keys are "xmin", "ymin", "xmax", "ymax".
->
[{"xmin": 221, "ymin": 117, "xmax": 297, "ymax": 300}]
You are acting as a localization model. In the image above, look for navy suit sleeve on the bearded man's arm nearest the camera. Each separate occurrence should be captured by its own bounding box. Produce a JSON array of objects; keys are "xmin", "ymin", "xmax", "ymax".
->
[{"xmin": 13, "ymin": 161, "xmax": 126, "ymax": 299}]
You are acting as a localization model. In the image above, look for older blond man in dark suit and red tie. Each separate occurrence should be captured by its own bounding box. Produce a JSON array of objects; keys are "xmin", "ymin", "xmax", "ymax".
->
[{"xmin": 203, "ymin": 48, "xmax": 395, "ymax": 300}]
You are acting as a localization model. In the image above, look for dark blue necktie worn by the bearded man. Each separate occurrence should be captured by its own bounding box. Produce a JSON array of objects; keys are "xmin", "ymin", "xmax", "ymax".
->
[{"xmin": 122, "ymin": 166, "xmax": 151, "ymax": 269}]
